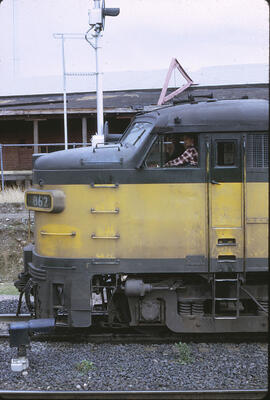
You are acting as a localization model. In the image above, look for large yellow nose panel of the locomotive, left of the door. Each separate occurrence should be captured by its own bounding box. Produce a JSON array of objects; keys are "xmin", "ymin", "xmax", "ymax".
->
[{"xmin": 35, "ymin": 183, "xmax": 206, "ymax": 260}]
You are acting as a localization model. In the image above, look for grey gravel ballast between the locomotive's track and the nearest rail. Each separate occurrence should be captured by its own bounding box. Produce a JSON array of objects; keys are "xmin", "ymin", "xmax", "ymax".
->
[{"xmin": 0, "ymin": 296, "xmax": 268, "ymax": 391}]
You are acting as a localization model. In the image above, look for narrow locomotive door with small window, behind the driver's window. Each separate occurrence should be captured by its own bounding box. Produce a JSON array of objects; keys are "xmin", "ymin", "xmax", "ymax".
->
[{"xmin": 208, "ymin": 134, "xmax": 245, "ymax": 272}]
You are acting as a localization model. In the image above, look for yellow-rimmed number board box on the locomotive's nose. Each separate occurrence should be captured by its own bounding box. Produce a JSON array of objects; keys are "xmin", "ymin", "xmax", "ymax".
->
[{"xmin": 24, "ymin": 189, "xmax": 65, "ymax": 213}]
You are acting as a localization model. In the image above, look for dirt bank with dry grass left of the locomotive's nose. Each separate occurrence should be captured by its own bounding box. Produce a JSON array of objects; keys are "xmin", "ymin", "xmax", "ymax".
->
[{"xmin": 0, "ymin": 203, "xmax": 33, "ymax": 283}]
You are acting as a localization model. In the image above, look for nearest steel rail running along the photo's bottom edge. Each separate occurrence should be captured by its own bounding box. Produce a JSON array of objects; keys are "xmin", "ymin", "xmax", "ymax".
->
[{"xmin": 0, "ymin": 389, "xmax": 268, "ymax": 400}]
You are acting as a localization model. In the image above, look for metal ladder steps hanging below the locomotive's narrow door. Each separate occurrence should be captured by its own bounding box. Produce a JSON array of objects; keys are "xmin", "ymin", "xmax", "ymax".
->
[{"xmin": 212, "ymin": 273, "xmax": 242, "ymax": 320}]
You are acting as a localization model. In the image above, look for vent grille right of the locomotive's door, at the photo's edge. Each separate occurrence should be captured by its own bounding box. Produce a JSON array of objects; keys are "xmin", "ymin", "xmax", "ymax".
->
[{"xmin": 247, "ymin": 134, "xmax": 269, "ymax": 168}]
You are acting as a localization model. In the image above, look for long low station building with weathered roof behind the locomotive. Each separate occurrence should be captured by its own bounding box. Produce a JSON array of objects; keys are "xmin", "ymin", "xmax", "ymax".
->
[{"xmin": 0, "ymin": 83, "xmax": 269, "ymax": 188}]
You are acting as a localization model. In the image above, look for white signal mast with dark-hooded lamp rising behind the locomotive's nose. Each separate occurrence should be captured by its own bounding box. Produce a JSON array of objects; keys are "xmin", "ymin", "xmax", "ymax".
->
[{"xmin": 85, "ymin": 0, "xmax": 120, "ymax": 147}]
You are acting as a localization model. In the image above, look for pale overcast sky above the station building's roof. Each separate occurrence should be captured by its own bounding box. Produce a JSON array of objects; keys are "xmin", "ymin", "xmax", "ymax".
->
[{"xmin": 0, "ymin": 0, "xmax": 269, "ymax": 94}]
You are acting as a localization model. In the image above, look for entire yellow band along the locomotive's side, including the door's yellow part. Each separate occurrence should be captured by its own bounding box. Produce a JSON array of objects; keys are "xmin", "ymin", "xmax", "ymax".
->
[{"xmin": 31, "ymin": 182, "xmax": 268, "ymax": 266}]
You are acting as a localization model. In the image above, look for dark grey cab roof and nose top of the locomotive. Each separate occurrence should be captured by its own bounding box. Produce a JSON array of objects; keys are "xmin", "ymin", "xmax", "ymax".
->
[{"xmin": 34, "ymin": 100, "xmax": 268, "ymax": 173}]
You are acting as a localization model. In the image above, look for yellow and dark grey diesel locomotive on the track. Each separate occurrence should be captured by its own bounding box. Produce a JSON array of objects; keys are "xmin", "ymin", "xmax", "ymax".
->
[{"xmin": 15, "ymin": 99, "xmax": 268, "ymax": 333}]
